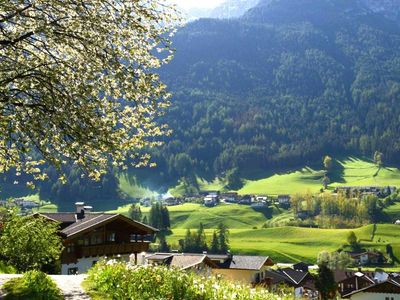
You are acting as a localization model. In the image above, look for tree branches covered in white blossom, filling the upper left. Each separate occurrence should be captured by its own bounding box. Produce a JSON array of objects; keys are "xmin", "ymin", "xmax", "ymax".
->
[{"xmin": 0, "ymin": 0, "xmax": 177, "ymax": 179}]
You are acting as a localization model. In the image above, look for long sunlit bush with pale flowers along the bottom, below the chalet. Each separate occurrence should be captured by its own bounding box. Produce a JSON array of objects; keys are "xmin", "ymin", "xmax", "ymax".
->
[{"xmin": 86, "ymin": 261, "xmax": 289, "ymax": 300}]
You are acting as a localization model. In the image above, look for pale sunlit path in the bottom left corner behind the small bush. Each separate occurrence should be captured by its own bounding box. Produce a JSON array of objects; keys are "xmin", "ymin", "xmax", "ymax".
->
[{"xmin": 0, "ymin": 274, "xmax": 90, "ymax": 300}]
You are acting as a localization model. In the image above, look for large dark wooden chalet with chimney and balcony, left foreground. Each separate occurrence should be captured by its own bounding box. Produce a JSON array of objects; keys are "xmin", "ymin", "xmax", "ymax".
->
[{"xmin": 35, "ymin": 202, "xmax": 158, "ymax": 275}]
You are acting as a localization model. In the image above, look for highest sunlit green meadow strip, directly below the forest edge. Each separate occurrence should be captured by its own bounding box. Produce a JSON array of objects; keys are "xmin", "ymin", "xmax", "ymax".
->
[{"xmin": 166, "ymin": 157, "xmax": 400, "ymax": 196}]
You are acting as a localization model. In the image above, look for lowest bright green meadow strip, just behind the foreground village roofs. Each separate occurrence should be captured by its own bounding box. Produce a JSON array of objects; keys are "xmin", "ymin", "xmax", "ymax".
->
[{"xmin": 169, "ymin": 224, "xmax": 400, "ymax": 262}]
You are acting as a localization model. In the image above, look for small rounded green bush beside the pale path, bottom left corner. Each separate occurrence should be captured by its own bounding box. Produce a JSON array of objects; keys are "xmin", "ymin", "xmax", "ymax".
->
[{"xmin": 3, "ymin": 271, "xmax": 64, "ymax": 300}]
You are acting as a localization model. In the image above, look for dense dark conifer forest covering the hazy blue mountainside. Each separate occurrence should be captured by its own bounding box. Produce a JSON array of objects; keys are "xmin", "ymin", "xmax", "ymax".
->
[{"xmin": 0, "ymin": 0, "xmax": 400, "ymax": 201}]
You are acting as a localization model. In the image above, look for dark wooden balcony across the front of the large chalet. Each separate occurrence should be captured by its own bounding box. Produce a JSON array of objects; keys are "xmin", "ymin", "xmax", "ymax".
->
[{"xmin": 79, "ymin": 242, "xmax": 150, "ymax": 257}]
